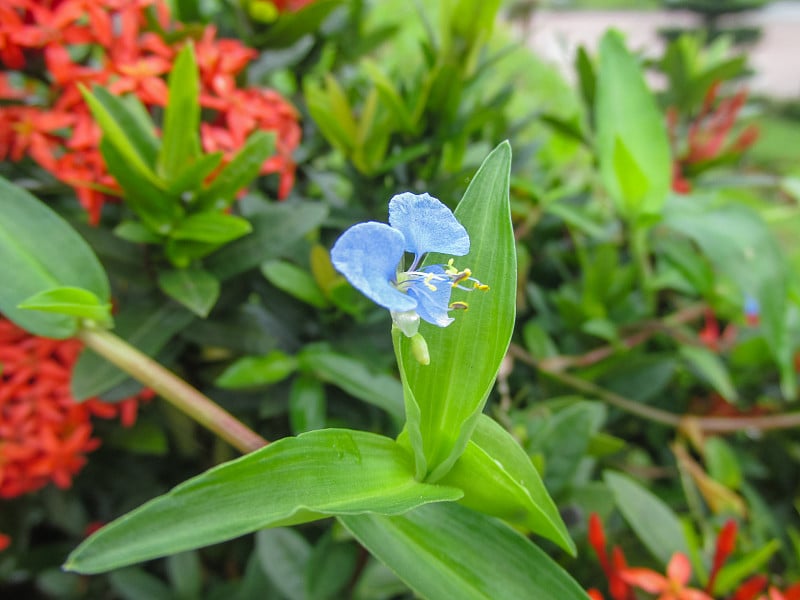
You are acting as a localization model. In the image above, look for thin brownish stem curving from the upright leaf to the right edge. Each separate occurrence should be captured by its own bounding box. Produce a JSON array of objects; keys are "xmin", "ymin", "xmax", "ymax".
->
[{"xmin": 508, "ymin": 344, "xmax": 800, "ymax": 433}]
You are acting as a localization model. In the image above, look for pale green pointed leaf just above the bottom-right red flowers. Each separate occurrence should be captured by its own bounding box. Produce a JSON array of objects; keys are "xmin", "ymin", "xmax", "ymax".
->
[{"xmin": 603, "ymin": 471, "xmax": 689, "ymax": 565}]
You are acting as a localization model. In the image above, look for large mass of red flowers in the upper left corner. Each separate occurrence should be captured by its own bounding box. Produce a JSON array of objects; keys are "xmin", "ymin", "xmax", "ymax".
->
[{"xmin": 0, "ymin": 0, "xmax": 301, "ymax": 223}]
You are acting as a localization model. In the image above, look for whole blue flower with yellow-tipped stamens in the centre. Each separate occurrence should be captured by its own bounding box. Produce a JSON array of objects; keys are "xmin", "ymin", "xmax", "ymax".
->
[{"xmin": 331, "ymin": 192, "xmax": 488, "ymax": 337}]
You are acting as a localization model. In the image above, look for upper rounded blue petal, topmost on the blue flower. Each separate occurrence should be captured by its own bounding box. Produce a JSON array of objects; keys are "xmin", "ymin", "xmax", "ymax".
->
[{"xmin": 389, "ymin": 192, "xmax": 469, "ymax": 256}]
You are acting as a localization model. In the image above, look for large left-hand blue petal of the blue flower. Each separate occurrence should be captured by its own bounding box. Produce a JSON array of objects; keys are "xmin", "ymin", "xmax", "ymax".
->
[{"xmin": 331, "ymin": 221, "xmax": 417, "ymax": 312}]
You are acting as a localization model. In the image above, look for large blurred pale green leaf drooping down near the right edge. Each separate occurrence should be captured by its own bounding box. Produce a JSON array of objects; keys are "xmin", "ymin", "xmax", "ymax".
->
[{"xmin": 664, "ymin": 196, "xmax": 797, "ymax": 397}]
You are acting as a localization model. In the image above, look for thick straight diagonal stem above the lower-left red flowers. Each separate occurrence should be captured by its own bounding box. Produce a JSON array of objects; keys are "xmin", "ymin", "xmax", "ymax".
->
[{"xmin": 77, "ymin": 327, "xmax": 269, "ymax": 453}]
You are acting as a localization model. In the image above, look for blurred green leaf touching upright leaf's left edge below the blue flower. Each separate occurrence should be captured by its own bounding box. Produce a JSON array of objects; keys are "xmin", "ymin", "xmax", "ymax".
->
[{"xmin": 297, "ymin": 347, "xmax": 403, "ymax": 420}]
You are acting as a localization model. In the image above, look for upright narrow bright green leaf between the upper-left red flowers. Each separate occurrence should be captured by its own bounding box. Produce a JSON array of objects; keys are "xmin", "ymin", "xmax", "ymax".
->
[{"xmin": 157, "ymin": 44, "xmax": 200, "ymax": 182}]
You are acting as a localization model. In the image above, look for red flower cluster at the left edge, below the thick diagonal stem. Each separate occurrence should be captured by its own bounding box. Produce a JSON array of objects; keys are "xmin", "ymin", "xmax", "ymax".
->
[{"xmin": 0, "ymin": 317, "xmax": 153, "ymax": 500}]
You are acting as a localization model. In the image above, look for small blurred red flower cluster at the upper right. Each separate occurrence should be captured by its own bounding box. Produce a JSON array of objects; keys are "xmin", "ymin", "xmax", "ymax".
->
[{"xmin": 667, "ymin": 82, "xmax": 758, "ymax": 194}]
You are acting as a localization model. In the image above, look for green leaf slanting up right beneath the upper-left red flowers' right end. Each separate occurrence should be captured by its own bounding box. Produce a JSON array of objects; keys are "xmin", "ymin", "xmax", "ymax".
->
[{"xmin": 197, "ymin": 131, "xmax": 275, "ymax": 210}]
